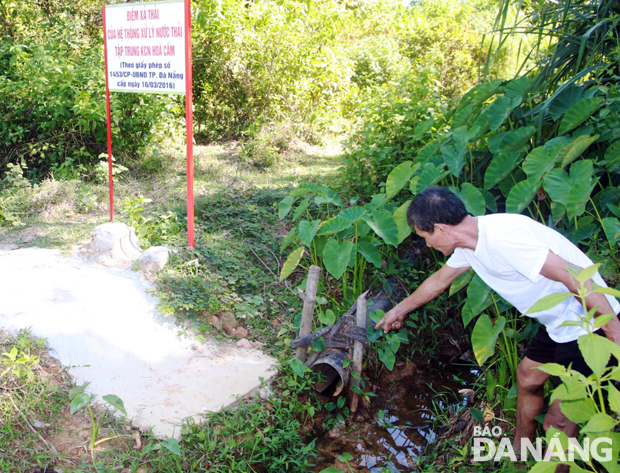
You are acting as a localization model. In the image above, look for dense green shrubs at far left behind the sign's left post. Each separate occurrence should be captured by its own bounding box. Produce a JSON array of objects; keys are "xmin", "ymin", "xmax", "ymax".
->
[{"xmin": 0, "ymin": 3, "xmax": 174, "ymax": 178}]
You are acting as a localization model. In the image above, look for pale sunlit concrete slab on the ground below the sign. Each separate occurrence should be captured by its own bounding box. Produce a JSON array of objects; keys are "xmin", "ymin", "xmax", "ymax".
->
[{"xmin": 0, "ymin": 247, "xmax": 276, "ymax": 437}]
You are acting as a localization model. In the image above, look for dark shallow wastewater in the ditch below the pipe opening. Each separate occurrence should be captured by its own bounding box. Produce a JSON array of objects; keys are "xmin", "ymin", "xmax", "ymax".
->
[{"xmin": 314, "ymin": 362, "xmax": 476, "ymax": 473}]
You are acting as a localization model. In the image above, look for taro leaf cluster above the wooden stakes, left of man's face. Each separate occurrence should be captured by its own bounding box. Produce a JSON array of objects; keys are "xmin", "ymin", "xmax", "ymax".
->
[{"xmin": 278, "ymin": 171, "xmax": 412, "ymax": 299}]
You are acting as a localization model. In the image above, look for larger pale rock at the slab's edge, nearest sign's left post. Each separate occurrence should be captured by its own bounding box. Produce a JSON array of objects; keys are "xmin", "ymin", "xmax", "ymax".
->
[{"xmin": 82, "ymin": 223, "xmax": 142, "ymax": 267}]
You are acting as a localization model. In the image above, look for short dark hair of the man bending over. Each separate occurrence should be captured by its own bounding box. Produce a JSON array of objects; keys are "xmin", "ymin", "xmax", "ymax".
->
[{"xmin": 407, "ymin": 186, "xmax": 469, "ymax": 233}]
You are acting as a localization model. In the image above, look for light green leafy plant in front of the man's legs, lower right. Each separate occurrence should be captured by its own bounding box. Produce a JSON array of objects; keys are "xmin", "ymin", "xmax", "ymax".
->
[{"xmin": 527, "ymin": 264, "xmax": 620, "ymax": 472}]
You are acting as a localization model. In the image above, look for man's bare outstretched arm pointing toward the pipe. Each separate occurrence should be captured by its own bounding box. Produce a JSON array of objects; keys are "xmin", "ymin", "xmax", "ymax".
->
[{"xmin": 375, "ymin": 264, "xmax": 469, "ymax": 333}]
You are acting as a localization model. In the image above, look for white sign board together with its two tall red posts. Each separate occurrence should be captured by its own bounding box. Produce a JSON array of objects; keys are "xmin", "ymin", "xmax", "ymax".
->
[{"xmin": 103, "ymin": 0, "xmax": 195, "ymax": 247}]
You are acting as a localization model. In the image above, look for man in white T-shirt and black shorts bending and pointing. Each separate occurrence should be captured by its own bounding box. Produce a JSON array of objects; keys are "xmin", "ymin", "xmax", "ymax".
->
[{"xmin": 376, "ymin": 186, "xmax": 620, "ymax": 451}]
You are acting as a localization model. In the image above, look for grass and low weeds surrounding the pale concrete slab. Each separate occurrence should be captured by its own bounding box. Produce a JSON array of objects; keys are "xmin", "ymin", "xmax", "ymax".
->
[{"xmin": 0, "ymin": 136, "xmax": 340, "ymax": 473}]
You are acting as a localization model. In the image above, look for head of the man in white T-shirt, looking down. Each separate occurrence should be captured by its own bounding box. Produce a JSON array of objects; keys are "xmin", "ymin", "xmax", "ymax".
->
[{"xmin": 407, "ymin": 186, "xmax": 469, "ymax": 255}]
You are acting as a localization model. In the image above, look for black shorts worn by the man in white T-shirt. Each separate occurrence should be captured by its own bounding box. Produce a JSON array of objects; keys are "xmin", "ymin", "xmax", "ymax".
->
[{"xmin": 525, "ymin": 325, "xmax": 605, "ymax": 378}]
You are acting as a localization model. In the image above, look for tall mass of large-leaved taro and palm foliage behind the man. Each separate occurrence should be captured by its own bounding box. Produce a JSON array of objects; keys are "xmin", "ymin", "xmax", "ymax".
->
[{"xmin": 346, "ymin": 0, "xmax": 620, "ymax": 284}]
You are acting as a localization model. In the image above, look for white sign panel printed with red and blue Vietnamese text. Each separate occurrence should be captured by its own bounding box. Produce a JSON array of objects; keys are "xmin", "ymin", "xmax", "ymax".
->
[{"xmin": 104, "ymin": 0, "xmax": 186, "ymax": 94}]
